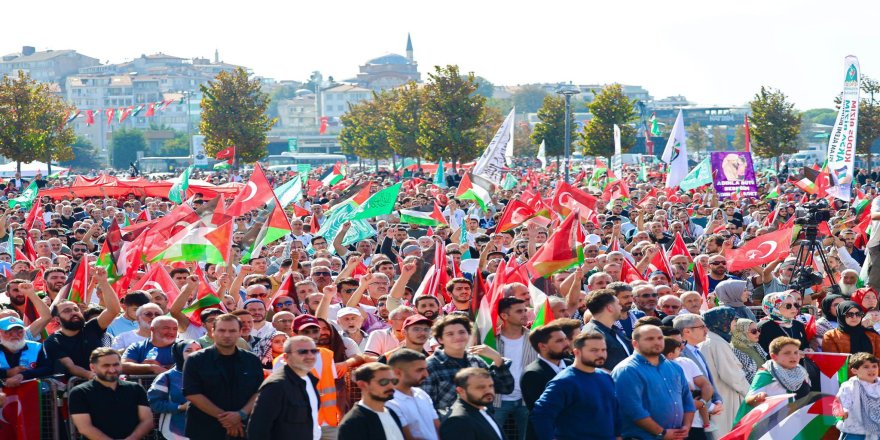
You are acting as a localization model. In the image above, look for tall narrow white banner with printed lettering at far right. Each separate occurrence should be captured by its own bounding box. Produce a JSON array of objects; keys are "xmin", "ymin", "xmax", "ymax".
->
[{"xmin": 828, "ymin": 55, "xmax": 861, "ymax": 201}]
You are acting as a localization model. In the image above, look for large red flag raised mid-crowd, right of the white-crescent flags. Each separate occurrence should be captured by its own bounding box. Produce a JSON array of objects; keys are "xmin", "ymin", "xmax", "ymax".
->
[{"xmin": 526, "ymin": 210, "xmax": 586, "ymax": 278}]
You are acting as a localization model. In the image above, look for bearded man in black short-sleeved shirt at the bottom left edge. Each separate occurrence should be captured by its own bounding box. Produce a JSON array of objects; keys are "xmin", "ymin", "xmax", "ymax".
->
[{"xmin": 69, "ymin": 347, "xmax": 153, "ymax": 438}]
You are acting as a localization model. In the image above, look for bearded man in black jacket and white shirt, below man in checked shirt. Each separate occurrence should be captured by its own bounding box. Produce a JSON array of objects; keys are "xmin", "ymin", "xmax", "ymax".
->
[{"xmin": 440, "ymin": 367, "xmax": 504, "ymax": 440}]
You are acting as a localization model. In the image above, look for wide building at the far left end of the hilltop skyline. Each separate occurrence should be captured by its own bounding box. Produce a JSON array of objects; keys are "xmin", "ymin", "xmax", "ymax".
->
[{"xmin": 0, "ymin": 46, "xmax": 100, "ymax": 91}]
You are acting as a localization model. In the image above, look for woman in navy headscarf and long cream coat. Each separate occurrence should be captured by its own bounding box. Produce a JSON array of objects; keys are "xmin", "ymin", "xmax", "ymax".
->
[{"xmin": 700, "ymin": 307, "xmax": 749, "ymax": 437}]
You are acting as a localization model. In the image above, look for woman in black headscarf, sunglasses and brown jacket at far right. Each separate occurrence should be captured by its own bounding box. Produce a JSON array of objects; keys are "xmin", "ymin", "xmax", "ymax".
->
[{"xmin": 823, "ymin": 301, "xmax": 880, "ymax": 356}]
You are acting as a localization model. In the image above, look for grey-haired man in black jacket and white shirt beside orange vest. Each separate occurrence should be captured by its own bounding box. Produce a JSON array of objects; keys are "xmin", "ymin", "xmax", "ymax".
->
[{"xmin": 247, "ymin": 336, "xmax": 321, "ymax": 440}]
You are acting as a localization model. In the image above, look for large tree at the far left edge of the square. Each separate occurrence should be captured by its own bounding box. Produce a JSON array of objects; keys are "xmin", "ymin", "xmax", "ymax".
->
[{"xmin": 0, "ymin": 70, "xmax": 76, "ymax": 170}]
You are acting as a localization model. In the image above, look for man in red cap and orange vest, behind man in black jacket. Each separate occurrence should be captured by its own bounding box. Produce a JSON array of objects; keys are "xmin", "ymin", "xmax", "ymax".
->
[{"xmin": 290, "ymin": 315, "xmax": 342, "ymax": 438}]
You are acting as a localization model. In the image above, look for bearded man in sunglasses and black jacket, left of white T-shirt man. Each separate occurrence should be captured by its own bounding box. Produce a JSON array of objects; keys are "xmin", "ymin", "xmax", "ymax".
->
[{"xmin": 338, "ymin": 362, "xmax": 404, "ymax": 440}]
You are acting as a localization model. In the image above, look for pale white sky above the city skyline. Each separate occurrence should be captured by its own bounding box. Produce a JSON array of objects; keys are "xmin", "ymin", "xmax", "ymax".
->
[{"xmin": 0, "ymin": 0, "xmax": 880, "ymax": 110}]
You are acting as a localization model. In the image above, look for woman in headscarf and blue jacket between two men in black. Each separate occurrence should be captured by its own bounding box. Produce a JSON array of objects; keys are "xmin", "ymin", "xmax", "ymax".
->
[{"xmin": 147, "ymin": 340, "xmax": 202, "ymax": 440}]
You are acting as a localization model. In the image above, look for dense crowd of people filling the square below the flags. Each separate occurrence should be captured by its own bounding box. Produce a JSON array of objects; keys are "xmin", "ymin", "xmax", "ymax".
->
[{"xmin": 0, "ymin": 162, "xmax": 880, "ymax": 440}]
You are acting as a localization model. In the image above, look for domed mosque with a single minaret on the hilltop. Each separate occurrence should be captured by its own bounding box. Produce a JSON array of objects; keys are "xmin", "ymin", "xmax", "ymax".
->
[{"xmin": 346, "ymin": 34, "xmax": 421, "ymax": 91}]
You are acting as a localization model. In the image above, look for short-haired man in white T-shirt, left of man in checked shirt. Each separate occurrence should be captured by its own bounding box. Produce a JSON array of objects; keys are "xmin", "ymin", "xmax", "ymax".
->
[{"xmin": 386, "ymin": 350, "xmax": 440, "ymax": 440}]
